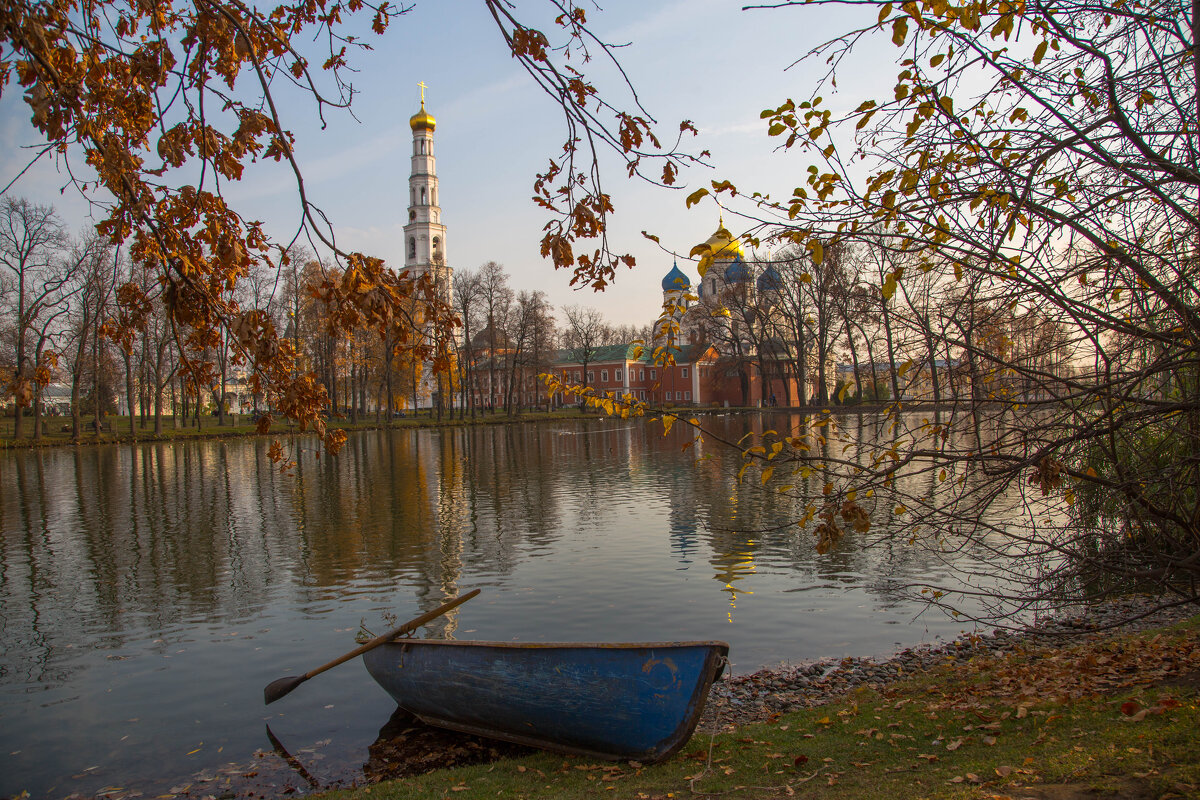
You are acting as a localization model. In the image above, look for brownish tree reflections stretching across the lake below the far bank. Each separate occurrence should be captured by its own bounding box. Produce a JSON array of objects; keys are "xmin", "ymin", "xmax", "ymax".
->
[{"xmin": 0, "ymin": 413, "xmax": 1041, "ymax": 681}]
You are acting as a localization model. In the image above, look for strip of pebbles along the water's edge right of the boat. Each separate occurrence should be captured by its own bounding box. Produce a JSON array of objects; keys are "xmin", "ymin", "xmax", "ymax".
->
[{"xmin": 700, "ymin": 597, "xmax": 1196, "ymax": 732}]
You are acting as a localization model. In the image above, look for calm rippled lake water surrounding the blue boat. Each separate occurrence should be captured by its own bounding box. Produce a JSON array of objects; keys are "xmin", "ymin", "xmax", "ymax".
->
[{"xmin": 0, "ymin": 414, "xmax": 1012, "ymax": 799}]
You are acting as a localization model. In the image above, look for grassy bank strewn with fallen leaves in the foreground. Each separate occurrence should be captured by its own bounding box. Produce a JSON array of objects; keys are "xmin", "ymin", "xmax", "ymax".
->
[{"xmin": 322, "ymin": 618, "xmax": 1200, "ymax": 800}]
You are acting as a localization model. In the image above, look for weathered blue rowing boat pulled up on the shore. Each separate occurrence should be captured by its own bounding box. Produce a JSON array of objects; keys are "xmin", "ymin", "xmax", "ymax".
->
[{"xmin": 362, "ymin": 639, "xmax": 730, "ymax": 763}]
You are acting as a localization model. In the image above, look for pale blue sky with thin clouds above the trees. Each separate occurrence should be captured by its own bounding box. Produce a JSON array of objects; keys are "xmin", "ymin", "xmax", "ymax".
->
[{"xmin": 0, "ymin": 0, "xmax": 898, "ymax": 325}]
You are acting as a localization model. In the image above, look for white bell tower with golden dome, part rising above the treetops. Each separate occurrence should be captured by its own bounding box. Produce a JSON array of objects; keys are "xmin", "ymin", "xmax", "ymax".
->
[{"xmin": 404, "ymin": 82, "xmax": 450, "ymax": 301}]
